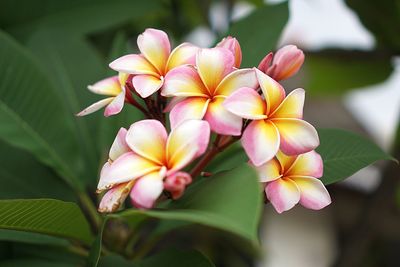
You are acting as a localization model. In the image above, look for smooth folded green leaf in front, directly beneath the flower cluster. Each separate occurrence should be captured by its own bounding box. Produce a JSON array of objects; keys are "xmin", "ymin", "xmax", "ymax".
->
[{"xmin": 119, "ymin": 164, "xmax": 262, "ymax": 246}]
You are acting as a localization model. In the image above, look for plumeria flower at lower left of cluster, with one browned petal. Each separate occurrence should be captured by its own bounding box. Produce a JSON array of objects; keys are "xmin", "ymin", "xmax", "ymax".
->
[{"xmin": 97, "ymin": 120, "xmax": 210, "ymax": 212}]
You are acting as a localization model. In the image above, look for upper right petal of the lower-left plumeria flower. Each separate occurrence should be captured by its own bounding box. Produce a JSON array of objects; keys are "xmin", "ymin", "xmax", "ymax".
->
[{"xmin": 167, "ymin": 120, "xmax": 210, "ymax": 175}]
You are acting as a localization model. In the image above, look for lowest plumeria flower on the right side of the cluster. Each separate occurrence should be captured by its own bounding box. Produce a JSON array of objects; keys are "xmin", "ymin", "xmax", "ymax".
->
[{"xmin": 256, "ymin": 151, "xmax": 331, "ymax": 213}]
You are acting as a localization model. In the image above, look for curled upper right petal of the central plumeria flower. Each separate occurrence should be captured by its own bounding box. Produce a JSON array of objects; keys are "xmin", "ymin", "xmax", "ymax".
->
[{"xmin": 214, "ymin": 69, "xmax": 258, "ymax": 96}]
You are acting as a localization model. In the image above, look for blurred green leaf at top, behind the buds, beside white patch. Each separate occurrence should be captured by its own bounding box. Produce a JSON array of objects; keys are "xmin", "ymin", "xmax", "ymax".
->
[{"xmin": 229, "ymin": 2, "xmax": 289, "ymax": 67}]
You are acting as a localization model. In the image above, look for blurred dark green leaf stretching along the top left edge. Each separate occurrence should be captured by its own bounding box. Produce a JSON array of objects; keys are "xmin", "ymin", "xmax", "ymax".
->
[{"xmin": 6, "ymin": 0, "xmax": 161, "ymax": 39}]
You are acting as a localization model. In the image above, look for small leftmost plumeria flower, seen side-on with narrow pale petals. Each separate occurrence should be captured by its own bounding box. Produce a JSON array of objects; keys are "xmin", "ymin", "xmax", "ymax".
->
[{"xmin": 76, "ymin": 73, "xmax": 128, "ymax": 117}]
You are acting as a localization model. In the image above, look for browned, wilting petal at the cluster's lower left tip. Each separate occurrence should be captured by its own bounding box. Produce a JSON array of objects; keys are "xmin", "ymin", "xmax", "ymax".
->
[{"xmin": 99, "ymin": 181, "xmax": 135, "ymax": 215}]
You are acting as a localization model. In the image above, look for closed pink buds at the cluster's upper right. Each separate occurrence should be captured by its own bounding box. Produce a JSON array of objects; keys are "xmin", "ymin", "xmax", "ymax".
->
[{"xmin": 258, "ymin": 45, "xmax": 304, "ymax": 81}]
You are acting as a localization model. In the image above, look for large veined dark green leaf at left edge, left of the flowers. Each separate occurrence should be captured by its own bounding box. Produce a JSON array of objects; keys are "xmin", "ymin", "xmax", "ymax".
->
[{"xmin": 0, "ymin": 32, "xmax": 82, "ymax": 187}]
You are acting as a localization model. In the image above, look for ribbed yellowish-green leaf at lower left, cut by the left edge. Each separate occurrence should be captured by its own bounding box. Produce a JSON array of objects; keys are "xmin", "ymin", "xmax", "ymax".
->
[{"xmin": 0, "ymin": 199, "xmax": 93, "ymax": 244}]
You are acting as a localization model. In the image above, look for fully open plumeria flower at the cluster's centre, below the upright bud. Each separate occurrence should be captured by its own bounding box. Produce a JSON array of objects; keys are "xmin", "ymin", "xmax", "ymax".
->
[{"xmin": 161, "ymin": 47, "xmax": 257, "ymax": 135}]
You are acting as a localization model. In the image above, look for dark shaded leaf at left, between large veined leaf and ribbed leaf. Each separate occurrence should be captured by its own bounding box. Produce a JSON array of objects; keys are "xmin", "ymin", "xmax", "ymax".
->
[{"xmin": 0, "ymin": 140, "xmax": 76, "ymax": 201}]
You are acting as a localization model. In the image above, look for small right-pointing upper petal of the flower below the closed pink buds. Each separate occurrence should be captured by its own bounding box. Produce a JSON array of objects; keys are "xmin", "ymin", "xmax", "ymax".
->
[{"xmin": 270, "ymin": 88, "xmax": 305, "ymax": 119}]
